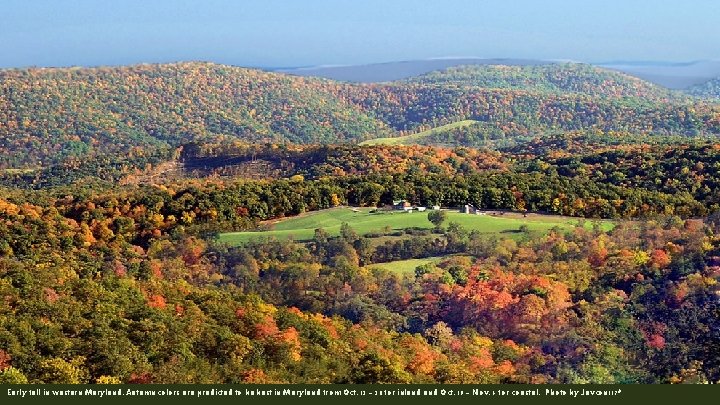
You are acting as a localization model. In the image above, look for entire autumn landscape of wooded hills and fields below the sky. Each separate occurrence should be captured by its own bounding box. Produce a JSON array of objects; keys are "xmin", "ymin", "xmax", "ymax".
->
[{"xmin": 0, "ymin": 61, "xmax": 720, "ymax": 384}]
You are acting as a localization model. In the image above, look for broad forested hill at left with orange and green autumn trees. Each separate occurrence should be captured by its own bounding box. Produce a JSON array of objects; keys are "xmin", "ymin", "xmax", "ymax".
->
[{"xmin": 0, "ymin": 63, "xmax": 386, "ymax": 167}]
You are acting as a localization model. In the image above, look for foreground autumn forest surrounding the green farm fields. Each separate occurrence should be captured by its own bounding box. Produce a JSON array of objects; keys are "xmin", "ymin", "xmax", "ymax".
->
[{"xmin": 0, "ymin": 152, "xmax": 720, "ymax": 384}]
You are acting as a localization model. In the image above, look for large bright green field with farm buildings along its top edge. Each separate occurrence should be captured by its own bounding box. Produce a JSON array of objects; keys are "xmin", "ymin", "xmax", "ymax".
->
[{"xmin": 219, "ymin": 207, "xmax": 613, "ymax": 245}]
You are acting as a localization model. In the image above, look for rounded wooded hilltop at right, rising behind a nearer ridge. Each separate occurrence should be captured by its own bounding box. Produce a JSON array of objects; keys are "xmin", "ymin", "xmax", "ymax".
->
[{"xmin": 407, "ymin": 63, "xmax": 679, "ymax": 100}]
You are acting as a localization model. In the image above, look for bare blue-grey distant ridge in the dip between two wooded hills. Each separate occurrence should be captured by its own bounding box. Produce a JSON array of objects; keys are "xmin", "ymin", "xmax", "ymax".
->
[{"xmin": 275, "ymin": 58, "xmax": 556, "ymax": 83}]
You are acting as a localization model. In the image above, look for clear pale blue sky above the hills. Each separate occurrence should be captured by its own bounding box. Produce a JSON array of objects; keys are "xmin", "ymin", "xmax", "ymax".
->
[{"xmin": 0, "ymin": 0, "xmax": 720, "ymax": 67}]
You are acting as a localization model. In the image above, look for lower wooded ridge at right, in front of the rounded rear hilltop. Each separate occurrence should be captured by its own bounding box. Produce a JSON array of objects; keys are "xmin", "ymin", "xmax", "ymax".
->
[{"xmin": 338, "ymin": 84, "xmax": 720, "ymax": 135}]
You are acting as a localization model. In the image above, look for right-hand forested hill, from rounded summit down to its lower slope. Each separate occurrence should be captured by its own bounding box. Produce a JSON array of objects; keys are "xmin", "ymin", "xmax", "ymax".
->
[{"xmin": 334, "ymin": 64, "xmax": 719, "ymax": 137}]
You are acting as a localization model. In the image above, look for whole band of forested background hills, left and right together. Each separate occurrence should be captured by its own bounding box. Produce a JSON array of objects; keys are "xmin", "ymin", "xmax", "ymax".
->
[{"xmin": 0, "ymin": 63, "xmax": 720, "ymax": 169}]
